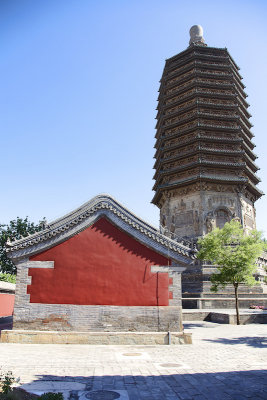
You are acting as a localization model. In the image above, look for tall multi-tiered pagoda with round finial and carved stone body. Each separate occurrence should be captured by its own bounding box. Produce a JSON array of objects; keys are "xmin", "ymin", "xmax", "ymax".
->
[{"xmin": 152, "ymin": 25, "xmax": 263, "ymax": 308}]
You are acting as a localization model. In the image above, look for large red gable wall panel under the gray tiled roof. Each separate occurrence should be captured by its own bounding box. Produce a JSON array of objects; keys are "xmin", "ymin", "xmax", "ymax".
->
[{"xmin": 28, "ymin": 218, "xmax": 171, "ymax": 306}]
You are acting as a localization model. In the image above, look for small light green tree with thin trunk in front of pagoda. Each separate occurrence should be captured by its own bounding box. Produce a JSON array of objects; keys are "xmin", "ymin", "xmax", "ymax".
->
[{"xmin": 197, "ymin": 220, "xmax": 265, "ymax": 325}]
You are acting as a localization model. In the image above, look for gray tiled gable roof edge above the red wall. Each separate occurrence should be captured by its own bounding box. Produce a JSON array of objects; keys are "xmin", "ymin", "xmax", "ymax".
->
[{"xmin": 7, "ymin": 195, "xmax": 195, "ymax": 264}]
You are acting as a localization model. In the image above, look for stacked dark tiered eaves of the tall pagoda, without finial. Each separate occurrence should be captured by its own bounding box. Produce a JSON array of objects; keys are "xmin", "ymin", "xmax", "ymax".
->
[{"xmin": 152, "ymin": 43, "xmax": 262, "ymax": 205}]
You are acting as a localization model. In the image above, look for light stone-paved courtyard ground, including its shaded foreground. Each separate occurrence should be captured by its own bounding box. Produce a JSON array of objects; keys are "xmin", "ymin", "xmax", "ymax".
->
[{"xmin": 0, "ymin": 322, "xmax": 267, "ymax": 400}]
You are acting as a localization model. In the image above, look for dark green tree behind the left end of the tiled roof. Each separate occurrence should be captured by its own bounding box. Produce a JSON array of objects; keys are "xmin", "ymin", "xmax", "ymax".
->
[{"xmin": 0, "ymin": 217, "xmax": 46, "ymax": 274}]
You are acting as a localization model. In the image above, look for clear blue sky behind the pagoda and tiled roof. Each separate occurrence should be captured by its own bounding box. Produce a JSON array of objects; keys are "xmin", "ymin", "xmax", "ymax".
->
[{"xmin": 0, "ymin": 0, "xmax": 267, "ymax": 236}]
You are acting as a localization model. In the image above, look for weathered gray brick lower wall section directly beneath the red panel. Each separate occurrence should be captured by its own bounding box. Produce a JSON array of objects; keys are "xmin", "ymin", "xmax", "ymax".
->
[{"xmin": 13, "ymin": 303, "xmax": 182, "ymax": 332}]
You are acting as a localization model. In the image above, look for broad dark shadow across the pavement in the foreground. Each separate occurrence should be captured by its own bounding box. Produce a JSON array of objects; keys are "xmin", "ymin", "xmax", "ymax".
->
[{"xmin": 17, "ymin": 370, "xmax": 267, "ymax": 400}]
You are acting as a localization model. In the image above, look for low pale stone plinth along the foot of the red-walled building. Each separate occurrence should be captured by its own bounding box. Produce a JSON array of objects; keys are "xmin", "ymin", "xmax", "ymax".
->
[{"xmin": 1, "ymin": 330, "xmax": 192, "ymax": 345}]
